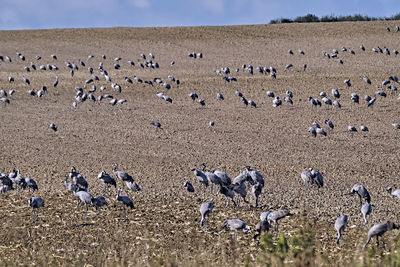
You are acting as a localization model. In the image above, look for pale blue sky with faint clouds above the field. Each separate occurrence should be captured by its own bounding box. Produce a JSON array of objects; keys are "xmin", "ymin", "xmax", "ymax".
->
[{"xmin": 0, "ymin": 0, "xmax": 400, "ymax": 30}]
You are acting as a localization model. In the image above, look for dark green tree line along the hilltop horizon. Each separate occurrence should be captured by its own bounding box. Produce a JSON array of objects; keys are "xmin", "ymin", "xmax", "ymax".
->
[{"xmin": 269, "ymin": 13, "xmax": 400, "ymax": 24}]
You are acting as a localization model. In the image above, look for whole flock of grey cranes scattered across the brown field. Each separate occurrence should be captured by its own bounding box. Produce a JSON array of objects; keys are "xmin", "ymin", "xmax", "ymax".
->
[{"xmin": 0, "ymin": 24, "xmax": 400, "ymax": 254}]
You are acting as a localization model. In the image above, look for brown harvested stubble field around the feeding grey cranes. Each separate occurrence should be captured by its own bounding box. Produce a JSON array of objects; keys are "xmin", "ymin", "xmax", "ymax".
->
[{"xmin": 0, "ymin": 22, "xmax": 400, "ymax": 265}]
